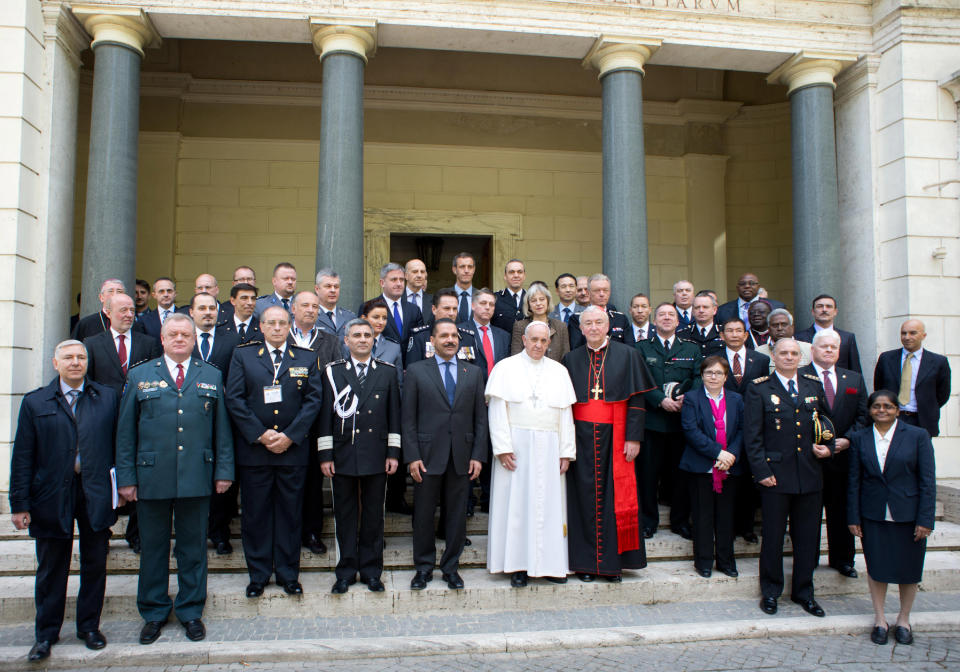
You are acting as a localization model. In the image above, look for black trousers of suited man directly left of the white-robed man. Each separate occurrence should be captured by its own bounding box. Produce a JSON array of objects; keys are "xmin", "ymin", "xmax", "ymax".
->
[{"xmin": 413, "ymin": 462, "xmax": 470, "ymax": 574}]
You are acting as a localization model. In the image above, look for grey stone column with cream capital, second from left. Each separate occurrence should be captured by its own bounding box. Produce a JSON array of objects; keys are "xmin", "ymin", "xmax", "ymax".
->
[{"xmin": 310, "ymin": 19, "xmax": 376, "ymax": 309}]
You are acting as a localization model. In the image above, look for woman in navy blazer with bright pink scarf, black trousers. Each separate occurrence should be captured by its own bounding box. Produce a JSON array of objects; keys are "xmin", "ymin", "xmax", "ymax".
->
[{"xmin": 680, "ymin": 355, "xmax": 743, "ymax": 578}]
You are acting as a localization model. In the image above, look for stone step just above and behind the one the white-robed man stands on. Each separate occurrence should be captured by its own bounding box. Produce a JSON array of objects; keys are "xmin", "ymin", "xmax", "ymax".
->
[{"xmin": 0, "ymin": 521, "xmax": 960, "ymax": 576}]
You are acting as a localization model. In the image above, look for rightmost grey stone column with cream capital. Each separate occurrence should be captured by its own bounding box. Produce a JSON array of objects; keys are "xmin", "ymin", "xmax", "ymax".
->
[{"xmin": 767, "ymin": 53, "xmax": 855, "ymax": 317}]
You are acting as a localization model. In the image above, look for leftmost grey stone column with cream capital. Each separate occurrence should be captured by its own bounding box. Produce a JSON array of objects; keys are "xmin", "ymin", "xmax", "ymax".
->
[{"xmin": 73, "ymin": 6, "xmax": 160, "ymax": 315}]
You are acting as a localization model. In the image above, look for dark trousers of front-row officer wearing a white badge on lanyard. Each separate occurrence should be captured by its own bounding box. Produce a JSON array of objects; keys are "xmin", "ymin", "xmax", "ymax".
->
[{"xmin": 239, "ymin": 466, "xmax": 307, "ymax": 585}]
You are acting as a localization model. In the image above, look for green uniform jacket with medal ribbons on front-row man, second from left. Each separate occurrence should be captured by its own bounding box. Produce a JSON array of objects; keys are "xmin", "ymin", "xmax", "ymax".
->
[{"xmin": 116, "ymin": 357, "xmax": 234, "ymax": 499}]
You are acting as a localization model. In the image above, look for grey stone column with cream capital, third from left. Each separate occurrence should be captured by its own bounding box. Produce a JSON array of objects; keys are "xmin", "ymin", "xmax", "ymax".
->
[{"xmin": 584, "ymin": 37, "xmax": 660, "ymax": 310}]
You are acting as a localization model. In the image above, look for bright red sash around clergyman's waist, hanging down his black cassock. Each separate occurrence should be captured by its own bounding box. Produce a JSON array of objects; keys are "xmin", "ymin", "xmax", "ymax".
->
[{"xmin": 573, "ymin": 399, "xmax": 640, "ymax": 553}]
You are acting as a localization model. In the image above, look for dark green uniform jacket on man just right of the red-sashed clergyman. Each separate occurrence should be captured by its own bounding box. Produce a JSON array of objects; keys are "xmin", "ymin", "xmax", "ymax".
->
[{"xmin": 635, "ymin": 335, "xmax": 703, "ymax": 432}]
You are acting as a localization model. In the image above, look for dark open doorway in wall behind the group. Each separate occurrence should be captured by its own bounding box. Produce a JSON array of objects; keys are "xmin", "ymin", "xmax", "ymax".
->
[{"xmin": 390, "ymin": 233, "xmax": 493, "ymax": 292}]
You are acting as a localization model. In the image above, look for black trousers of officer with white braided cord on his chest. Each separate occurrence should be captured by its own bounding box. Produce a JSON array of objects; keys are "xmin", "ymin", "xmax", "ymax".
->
[{"xmin": 333, "ymin": 473, "xmax": 387, "ymax": 581}]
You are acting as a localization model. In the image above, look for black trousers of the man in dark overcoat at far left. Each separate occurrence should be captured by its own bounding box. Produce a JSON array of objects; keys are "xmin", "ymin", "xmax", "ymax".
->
[{"xmin": 34, "ymin": 476, "xmax": 110, "ymax": 642}]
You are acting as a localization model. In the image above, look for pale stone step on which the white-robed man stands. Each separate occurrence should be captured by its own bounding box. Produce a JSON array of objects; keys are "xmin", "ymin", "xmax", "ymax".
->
[{"xmin": 0, "ymin": 551, "xmax": 960, "ymax": 625}]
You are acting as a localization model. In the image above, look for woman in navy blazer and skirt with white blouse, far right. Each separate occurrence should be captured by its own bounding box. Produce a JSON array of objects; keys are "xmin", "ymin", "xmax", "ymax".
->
[{"xmin": 847, "ymin": 390, "xmax": 937, "ymax": 644}]
